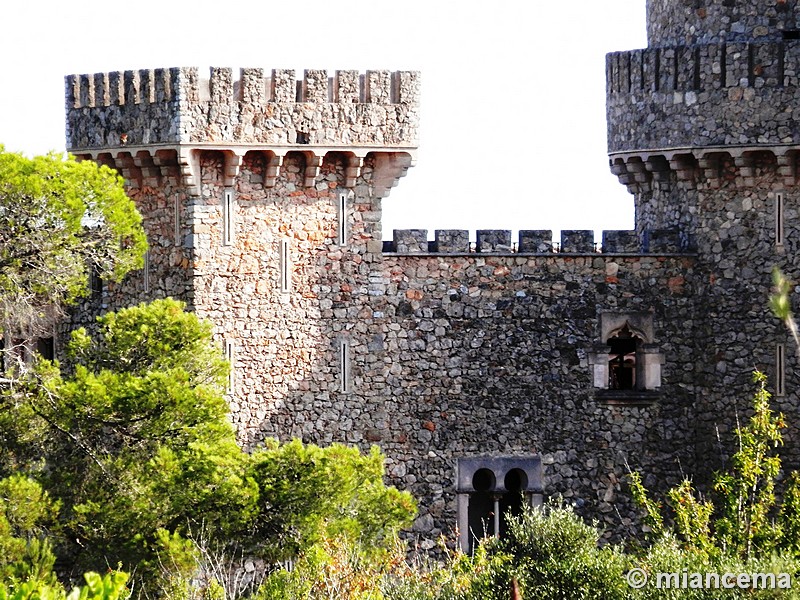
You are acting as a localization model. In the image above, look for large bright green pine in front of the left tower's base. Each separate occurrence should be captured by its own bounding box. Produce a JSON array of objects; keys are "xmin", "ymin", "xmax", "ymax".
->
[{"xmin": 14, "ymin": 300, "xmax": 258, "ymax": 576}]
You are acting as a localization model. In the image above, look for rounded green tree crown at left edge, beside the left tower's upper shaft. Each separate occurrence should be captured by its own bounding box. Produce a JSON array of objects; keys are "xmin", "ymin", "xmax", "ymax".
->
[{"xmin": 0, "ymin": 146, "xmax": 147, "ymax": 325}]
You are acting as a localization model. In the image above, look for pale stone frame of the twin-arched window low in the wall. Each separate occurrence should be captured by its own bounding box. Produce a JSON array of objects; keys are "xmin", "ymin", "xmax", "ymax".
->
[{"xmin": 455, "ymin": 454, "xmax": 544, "ymax": 552}]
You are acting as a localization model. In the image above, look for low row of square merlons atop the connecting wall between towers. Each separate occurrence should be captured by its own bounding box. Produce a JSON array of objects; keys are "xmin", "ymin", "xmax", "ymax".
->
[{"xmin": 383, "ymin": 229, "xmax": 693, "ymax": 255}]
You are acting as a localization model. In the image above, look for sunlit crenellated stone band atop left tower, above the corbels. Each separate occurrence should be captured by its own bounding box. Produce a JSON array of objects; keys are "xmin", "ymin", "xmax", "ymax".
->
[{"xmin": 65, "ymin": 67, "xmax": 420, "ymax": 151}]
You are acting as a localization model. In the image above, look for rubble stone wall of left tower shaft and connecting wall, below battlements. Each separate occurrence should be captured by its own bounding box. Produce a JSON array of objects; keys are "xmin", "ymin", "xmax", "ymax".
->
[{"xmin": 62, "ymin": 146, "xmax": 699, "ymax": 549}]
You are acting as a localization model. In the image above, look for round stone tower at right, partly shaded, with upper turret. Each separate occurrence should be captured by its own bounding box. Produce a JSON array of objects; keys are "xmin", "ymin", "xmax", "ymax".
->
[{"xmin": 607, "ymin": 0, "xmax": 800, "ymax": 478}]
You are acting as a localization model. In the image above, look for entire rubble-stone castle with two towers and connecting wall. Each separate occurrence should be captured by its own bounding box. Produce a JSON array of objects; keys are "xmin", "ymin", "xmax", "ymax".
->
[{"xmin": 61, "ymin": 0, "xmax": 800, "ymax": 550}]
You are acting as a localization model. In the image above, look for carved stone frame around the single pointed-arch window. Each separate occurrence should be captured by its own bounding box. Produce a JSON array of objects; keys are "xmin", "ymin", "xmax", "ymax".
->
[{"xmin": 589, "ymin": 311, "xmax": 664, "ymax": 405}]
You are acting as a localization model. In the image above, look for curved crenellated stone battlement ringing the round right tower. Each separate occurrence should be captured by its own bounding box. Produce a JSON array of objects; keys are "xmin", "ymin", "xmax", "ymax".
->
[{"xmin": 606, "ymin": 41, "xmax": 800, "ymax": 153}]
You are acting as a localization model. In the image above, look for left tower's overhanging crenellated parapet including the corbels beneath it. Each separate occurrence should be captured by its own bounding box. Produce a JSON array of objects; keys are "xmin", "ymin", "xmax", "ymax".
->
[{"xmin": 65, "ymin": 67, "xmax": 419, "ymax": 197}]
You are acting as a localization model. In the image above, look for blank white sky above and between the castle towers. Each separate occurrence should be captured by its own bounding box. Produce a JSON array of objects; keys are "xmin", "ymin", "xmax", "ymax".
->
[{"xmin": 0, "ymin": 0, "xmax": 646, "ymax": 239}]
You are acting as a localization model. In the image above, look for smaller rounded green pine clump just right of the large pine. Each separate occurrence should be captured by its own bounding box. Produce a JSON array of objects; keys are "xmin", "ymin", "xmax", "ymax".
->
[{"xmin": 249, "ymin": 440, "xmax": 416, "ymax": 560}]
